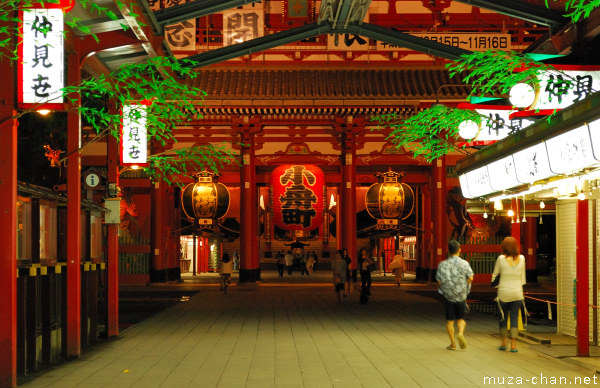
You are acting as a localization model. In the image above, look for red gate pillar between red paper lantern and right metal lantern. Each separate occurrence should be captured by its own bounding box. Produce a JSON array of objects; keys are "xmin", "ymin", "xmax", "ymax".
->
[{"xmin": 339, "ymin": 132, "xmax": 358, "ymax": 269}]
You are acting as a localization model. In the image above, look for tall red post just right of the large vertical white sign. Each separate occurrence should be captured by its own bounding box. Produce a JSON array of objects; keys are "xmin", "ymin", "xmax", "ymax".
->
[{"xmin": 66, "ymin": 39, "xmax": 81, "ymax": 357}]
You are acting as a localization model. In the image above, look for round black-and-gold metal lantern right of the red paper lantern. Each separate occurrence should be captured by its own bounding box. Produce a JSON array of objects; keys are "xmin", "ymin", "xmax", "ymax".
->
[{"xmin": 365, "ymin": 170, "xmax": 415, "ymax": 225}]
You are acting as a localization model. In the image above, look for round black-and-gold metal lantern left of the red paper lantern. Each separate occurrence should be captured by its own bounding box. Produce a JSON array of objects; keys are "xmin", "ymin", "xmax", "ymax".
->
[{"xmin": 181, "ymin": 171, "xmax": 229, "ymax": 224}]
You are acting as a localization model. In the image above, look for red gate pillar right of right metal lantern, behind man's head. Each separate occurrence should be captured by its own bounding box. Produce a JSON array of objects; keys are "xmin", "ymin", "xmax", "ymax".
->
[{"xmin": 430, "ymin": 157, "xmax": 448, "ymax": 281}]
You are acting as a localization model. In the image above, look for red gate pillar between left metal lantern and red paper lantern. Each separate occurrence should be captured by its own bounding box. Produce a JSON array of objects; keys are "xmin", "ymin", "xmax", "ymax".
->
[{"xmin": 239, "ymin": 134, "xmax": 260, "ymax": 282}]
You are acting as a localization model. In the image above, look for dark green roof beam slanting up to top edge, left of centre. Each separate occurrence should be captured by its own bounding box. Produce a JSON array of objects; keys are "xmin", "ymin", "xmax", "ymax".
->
[{"xmin": 153, "ymin": 0, "xmax": 262, "ymax": 33}]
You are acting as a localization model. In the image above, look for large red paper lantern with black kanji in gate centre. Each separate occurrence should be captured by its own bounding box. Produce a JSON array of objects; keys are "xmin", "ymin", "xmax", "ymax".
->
[{"xmin": 271, "ymin": 164, "xmax": 325, "ymax": 230}]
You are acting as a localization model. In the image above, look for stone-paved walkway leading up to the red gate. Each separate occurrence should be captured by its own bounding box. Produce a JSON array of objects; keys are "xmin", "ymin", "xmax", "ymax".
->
[{"xmin": 24, "ymin": 274, "xmax": 600, "ymax": 388}]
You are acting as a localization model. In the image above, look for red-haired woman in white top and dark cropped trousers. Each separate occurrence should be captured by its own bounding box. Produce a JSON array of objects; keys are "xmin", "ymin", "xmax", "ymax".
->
[{"xmin": 492, "ymin": 237, "xmax": 526, "ymax": 352}]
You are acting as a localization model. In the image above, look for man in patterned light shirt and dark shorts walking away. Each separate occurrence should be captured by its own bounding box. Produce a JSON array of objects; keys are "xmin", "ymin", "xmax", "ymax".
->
[{"xmin": 435, "ymin": 240, "xmax": 473, "ymax": 350}]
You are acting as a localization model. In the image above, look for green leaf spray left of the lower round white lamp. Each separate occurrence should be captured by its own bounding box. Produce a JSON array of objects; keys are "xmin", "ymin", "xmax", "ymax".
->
[{"xmin": 371, "ymin": 105, "xmax": 483, "ymax": 162}]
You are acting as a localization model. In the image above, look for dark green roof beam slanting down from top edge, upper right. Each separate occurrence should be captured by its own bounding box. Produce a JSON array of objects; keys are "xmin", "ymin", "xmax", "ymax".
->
[{"xmin": 456, "ymin": 0, "xmax": 570, "ymax": 31}]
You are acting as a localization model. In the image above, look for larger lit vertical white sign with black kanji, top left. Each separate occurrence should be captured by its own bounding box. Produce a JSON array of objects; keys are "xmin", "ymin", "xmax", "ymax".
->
[{"xmin": 18, "ymin": 8, "xmax": 65, "ymax": 109}]
